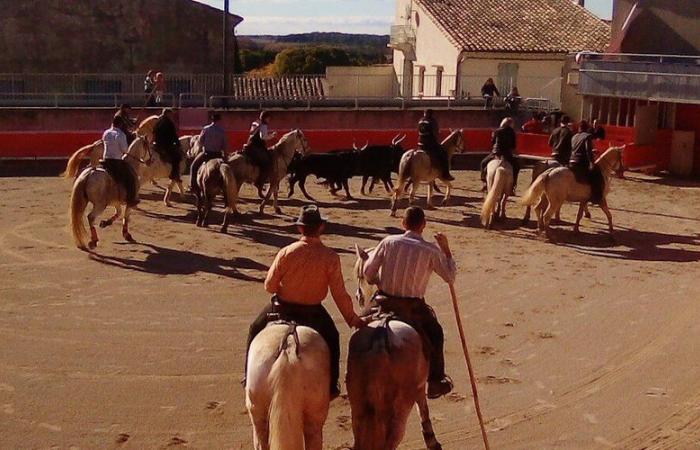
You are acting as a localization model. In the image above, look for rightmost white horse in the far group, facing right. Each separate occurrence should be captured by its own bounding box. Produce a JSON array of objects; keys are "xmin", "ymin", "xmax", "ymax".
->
[{"xmin": 521, "ymin": 147, "xmax": 624, "ymax": 236}]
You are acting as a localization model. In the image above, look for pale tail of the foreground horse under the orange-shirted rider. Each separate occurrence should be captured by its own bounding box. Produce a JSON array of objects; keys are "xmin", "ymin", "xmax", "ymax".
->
[{"xmin": 268, "ymin": 350, "xmax": 304, "ymax": 450}]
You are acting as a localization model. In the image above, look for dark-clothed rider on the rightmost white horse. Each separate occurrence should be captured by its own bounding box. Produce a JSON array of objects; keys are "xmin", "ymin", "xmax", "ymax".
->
[{"xmin": 569, "ymin": 120, "xmax": 605, "ymax": 204}]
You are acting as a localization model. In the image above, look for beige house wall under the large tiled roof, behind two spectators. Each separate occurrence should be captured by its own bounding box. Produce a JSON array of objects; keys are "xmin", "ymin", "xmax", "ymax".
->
[{"xmin": 459, "ymin": 53, "xmax": 565, "ymax": 105}]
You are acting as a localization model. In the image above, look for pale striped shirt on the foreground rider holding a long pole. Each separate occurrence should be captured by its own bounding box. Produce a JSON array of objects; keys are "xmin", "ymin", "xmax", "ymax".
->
[{"xmin": 365, "ymin": 231, "xmax": 457, "ymax": 298}]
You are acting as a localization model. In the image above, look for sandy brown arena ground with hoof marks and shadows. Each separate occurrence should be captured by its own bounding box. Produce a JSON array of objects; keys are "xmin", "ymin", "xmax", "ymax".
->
[{"xmin": 0, "ymin": 171, "xmax": 700, "ymax": 449}]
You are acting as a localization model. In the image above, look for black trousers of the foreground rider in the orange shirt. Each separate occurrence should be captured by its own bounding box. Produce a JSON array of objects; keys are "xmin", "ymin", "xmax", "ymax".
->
[{"xmin": 245, "ymin": 297, "xmax": 340, "ymax": 392}]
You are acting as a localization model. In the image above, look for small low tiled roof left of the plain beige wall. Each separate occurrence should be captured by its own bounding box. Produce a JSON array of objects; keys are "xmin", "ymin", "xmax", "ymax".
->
[{"xmin": 232, "ymin": 75, "xmax": 324, "ymax": 100}]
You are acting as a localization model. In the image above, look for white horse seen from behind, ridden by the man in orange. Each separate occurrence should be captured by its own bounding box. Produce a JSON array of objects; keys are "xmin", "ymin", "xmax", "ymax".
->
[{"xmin": 245, "ymin": 323, "xmax": 331, "ymax": 450}]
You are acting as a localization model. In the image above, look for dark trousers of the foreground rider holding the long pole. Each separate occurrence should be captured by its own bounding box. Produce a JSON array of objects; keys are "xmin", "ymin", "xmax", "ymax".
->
[{"xmin": 375, "ymin": 294, "xmax": 445, "ymax": 381}]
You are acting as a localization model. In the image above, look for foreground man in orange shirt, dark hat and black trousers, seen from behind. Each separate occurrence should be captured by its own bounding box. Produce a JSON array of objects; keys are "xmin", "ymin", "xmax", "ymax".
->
[{"xmin": 246, "ymin": 205, "xmax": 365, "ymax": 399}]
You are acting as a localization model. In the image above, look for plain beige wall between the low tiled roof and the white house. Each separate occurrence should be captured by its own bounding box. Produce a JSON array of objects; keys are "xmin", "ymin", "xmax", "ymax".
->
[{"xmin": 325, "ymin": 64, "xmax": 399, "ymax": 98}]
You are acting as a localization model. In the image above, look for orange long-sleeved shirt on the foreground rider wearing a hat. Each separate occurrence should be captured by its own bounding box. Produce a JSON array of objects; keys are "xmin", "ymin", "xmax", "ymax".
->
[{"xmin": 265, "ymin": 236, "xmax": 355, "ymax": 325}]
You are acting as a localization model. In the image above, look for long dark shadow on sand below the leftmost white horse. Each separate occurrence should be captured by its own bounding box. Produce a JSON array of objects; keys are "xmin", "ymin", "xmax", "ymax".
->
[{"xmin": 90, "ymin": 244, "xmax": 268, "ymax": 282}]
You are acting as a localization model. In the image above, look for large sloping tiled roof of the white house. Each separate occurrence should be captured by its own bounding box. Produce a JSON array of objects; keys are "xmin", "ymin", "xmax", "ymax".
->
[{"xmin": 417, "ymin": 0, "xmax": 610, "ymax": 53}]
